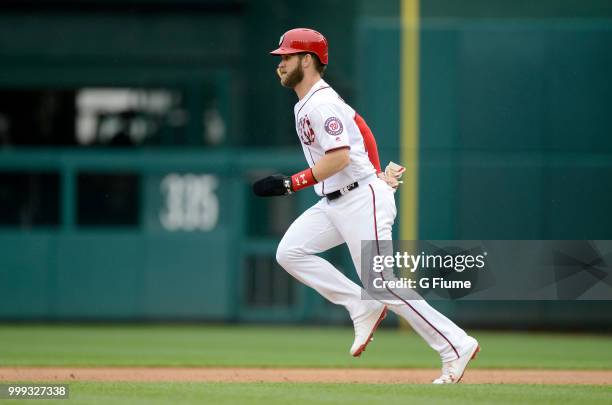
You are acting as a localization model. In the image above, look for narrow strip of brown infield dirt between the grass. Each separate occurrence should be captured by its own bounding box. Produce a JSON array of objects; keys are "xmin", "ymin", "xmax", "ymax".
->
[{"xmin": 0, "ymin": 367, "xmax": 612, "ymax": 385}]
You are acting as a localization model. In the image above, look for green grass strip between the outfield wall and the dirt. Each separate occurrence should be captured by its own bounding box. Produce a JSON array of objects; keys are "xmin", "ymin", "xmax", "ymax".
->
[{"xmin": 0, "ymin": 325, "xmax": 612, "ymax": 369}]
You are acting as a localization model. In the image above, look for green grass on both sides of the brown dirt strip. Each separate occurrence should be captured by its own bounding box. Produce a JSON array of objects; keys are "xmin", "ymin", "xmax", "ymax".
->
[{"xmin": 0, "ymin": 325, "xmax": 612, "ymax": 405}]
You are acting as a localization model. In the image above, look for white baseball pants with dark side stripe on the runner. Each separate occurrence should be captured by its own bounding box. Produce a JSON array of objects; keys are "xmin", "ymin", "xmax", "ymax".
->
[{"xmin": 276, "ymin": 175, "xmax": 474, "ymax": 361}]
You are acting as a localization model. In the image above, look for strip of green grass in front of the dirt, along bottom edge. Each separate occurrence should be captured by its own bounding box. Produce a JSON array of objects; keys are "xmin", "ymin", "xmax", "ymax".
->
[{"xmin": 0, "ymin": 382, "xmax": 612, "ymax": 405}]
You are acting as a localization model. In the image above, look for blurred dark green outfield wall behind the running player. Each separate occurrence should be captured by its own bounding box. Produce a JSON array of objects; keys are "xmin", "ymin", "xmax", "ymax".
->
[{"xmin": 0, "ymin": 0, "xmax": 612, "ymax": 329}]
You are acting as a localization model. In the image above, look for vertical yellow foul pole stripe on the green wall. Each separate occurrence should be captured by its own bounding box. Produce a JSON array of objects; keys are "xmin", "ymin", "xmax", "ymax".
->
[{"xmin": 400, "ymin": 0, "xmax": 419, "ymax": 240}]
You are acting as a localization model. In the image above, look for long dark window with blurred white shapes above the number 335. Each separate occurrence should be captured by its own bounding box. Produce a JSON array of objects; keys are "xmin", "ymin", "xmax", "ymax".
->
[{"xmin": 0, "ymin": 83, "xmax": 228, "ymax": 148}]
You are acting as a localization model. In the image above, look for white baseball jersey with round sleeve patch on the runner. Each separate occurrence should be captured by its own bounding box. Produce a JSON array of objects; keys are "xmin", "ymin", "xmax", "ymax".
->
[{"xmin": 294, "ymin": 79, "xmax": 376, "ymax": 196}]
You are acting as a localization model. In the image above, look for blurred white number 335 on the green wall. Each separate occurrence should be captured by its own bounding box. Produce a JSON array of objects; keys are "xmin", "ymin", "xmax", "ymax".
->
[{"xmin": 159, "ymin": 173, "xmax": 219, "ymax": 231}]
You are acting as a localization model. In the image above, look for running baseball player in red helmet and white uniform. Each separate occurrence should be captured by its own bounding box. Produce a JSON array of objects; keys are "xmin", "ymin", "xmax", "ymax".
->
[{"xmin": 253, "ymin": 28, "xmax": 479, "ymax": 384}]
